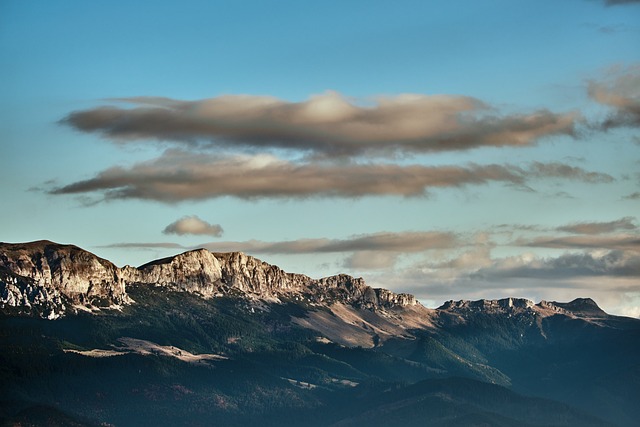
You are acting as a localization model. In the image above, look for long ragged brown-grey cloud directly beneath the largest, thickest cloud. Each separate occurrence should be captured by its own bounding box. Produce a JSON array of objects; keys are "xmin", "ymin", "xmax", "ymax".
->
[{"xmin": 49, "ymin": 150, "xmax": 613, "ymax": 203}]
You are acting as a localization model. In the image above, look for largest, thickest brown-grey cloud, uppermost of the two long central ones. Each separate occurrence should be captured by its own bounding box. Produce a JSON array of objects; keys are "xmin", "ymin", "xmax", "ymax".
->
[{"xmin": 61, "ymin": 91, "xmax": 577, "ymax": 157}]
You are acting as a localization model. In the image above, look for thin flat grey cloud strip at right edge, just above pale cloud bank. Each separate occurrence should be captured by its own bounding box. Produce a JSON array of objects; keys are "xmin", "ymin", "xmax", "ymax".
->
[{"xmin": 514, "ymin": 234, "xmax": 640, "ymax": 252}]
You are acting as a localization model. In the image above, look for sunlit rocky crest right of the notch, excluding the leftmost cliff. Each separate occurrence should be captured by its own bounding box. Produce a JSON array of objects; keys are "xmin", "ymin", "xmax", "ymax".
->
[{"xmin": 130, "ymin": 249, "xmax": 419, "ymax": 310}]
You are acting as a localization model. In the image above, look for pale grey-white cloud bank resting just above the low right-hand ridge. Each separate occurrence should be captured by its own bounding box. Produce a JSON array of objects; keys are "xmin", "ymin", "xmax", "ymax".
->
[{"xmin": 369, "ymin": 250, "xmax": 640, "ymax": 316}]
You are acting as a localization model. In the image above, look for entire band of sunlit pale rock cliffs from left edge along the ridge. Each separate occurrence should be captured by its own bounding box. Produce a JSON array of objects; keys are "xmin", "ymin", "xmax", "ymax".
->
[{"xmin": 0, "ymin": 241, "xmax": 419, "ymax": 317}]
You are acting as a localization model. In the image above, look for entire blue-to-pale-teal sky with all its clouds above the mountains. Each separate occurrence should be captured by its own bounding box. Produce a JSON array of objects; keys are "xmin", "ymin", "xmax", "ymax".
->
[{"xmin": 0, "ymin": 0, "xmax": 640, "ymax": 317}]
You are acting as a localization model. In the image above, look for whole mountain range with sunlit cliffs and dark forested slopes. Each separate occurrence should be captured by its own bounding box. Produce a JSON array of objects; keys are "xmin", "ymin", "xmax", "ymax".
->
[{"xmin": 0, "ymin": 241, "xmax": 640, "ymax": 426}]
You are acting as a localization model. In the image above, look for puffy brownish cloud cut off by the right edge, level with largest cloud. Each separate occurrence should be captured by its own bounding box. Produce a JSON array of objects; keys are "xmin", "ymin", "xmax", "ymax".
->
[{"xmin": 588, "ymin": 65, "xmax": 640, "ymax": 130}]
